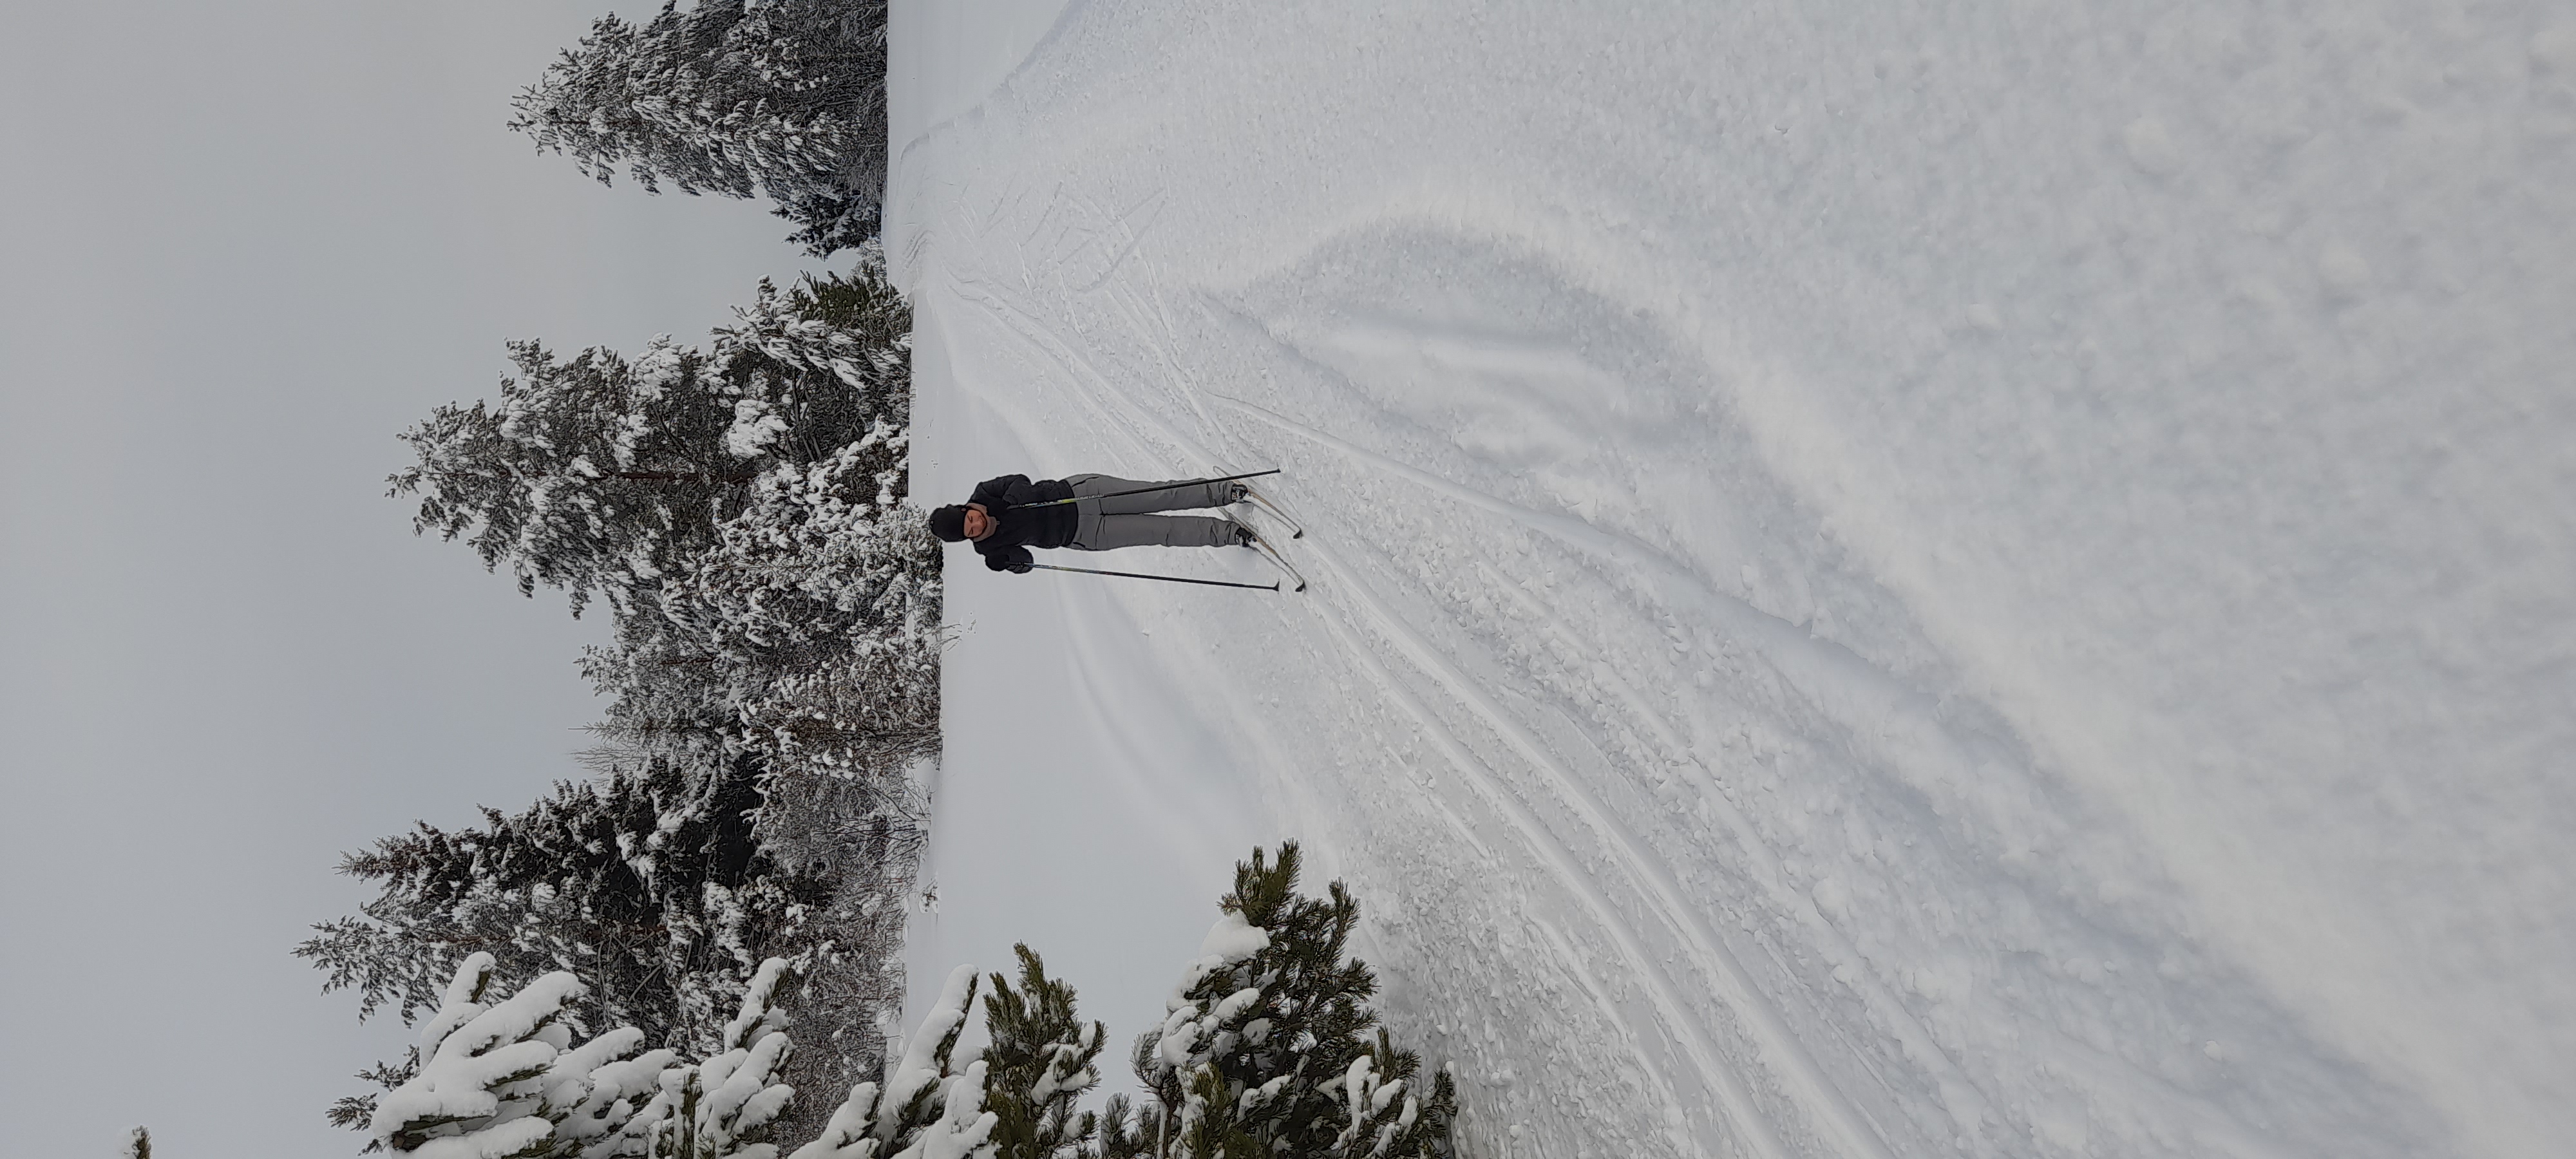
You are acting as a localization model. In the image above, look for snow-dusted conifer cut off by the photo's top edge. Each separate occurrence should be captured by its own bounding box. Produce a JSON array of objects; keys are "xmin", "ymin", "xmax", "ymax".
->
[{"xmin": 510, "ymin": 0, "xmax": 886, "ymax": 255}]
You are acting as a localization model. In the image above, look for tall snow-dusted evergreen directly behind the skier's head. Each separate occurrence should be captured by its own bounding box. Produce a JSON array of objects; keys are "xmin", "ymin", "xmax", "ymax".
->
[{"xmin": 389, "ymin": 247, "xmax": 912, "ymax": 626}]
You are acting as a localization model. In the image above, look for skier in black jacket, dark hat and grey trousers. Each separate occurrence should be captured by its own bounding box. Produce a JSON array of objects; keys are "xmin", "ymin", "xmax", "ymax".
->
[{"xmin": 930, "ymin": 474, "xmax": 1257, "ymax": 574}]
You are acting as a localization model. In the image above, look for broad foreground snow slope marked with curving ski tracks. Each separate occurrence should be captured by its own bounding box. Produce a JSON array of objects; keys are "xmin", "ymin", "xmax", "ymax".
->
[{"xmin": 889, "ymin": 0, "xmax": 2576, "ymax": 1159}]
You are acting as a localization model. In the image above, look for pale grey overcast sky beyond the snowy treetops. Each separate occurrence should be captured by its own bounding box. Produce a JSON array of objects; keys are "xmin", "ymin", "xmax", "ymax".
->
[{"xmin": 0, "ymin": 0, "xmax": 835, "ymax": 1159}]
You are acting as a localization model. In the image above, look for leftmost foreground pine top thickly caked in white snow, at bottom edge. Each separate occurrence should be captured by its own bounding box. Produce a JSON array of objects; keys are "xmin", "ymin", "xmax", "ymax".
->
[{"xmin": 368, "ymin": 953, "xmax": 675, "ymax": 1159}]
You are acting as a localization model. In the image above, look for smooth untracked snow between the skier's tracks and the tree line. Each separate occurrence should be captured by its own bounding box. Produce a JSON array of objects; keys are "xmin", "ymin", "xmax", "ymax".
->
[{"xmin": 896, "ymin": 292, "xmax": 1270, "ymax": 1092}]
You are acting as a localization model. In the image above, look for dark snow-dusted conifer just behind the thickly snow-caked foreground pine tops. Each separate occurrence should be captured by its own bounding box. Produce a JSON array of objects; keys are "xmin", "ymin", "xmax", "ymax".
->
[{"xmin": 296, "ymin": 760, "xmax": 829, "ymax": 1128}]
